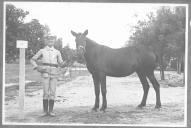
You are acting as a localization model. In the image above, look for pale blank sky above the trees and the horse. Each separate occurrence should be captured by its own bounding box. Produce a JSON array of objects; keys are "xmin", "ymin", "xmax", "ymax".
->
[{"xmin": 4, "ymin": 2, "xmax": 181, "ymax": 49}]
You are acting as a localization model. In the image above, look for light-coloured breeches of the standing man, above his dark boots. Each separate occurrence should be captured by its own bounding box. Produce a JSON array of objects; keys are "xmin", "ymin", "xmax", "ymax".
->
[{"xmin": 43, "ymin": 77, "xmax": 57, "ymax": 100}]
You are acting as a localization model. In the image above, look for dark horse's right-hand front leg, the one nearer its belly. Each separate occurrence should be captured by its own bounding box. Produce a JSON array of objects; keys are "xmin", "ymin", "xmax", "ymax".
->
[{"xmin": 100, "ymin": 74, "xmax": 107, "ymax": 111}]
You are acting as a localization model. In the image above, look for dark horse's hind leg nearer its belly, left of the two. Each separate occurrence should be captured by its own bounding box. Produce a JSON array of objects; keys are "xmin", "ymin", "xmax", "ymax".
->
[{"xmin": 137, "ymin": 72, "xmax": 149, "ymax": 107}]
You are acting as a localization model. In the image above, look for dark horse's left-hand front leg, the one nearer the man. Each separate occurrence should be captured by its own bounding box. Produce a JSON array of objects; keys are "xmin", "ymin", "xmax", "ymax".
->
[{"xmin": 92, "ymin": 74, "xmax": 100, "ymax": 111}]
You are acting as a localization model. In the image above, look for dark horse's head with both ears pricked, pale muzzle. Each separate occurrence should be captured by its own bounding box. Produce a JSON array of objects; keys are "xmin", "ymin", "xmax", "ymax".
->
[{"xmin": 71, "ymin": 30, "xmax": 88, "ymax": 53}]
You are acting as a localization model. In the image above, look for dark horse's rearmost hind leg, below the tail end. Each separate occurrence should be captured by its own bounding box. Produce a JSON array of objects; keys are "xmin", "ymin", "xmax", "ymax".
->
[{"xmin": 147, "ymin": 71, "xmax": 161, "ymax": 108}]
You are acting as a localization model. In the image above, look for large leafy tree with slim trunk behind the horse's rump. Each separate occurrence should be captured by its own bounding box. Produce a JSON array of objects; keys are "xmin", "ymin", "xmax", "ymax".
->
[{"xmin": 130, "ymin": 7, "xmax": 185, "ymax": 80}]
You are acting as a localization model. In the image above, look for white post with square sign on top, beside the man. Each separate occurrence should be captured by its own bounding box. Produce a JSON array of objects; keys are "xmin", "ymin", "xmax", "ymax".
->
[{"xmin": 17, "ymin": 40, "xmax": 28, "ymax": 119}]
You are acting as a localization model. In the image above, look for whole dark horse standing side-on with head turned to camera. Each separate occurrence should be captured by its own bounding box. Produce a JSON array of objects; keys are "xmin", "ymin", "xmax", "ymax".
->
[{"xmin": 71, "ymin": 30, "xmax": 161, "ymax": 111}]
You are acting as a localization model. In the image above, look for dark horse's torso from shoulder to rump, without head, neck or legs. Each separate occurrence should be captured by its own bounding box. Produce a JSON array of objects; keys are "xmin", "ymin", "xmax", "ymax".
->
[{"xmin": 86, "ymin": 40, "xmax": 155, "ymax": 77}]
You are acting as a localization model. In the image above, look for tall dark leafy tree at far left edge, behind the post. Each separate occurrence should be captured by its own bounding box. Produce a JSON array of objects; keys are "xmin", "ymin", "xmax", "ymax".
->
[{"xmin": 6, "ymin": 4, "xmax": 29, "ymax": 62}]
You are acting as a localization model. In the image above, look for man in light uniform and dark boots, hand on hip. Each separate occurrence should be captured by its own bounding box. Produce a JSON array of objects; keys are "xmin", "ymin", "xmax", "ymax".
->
[{"xmin": 31, "ymin": 36, "xmax": 65, "ymax": 116}]
